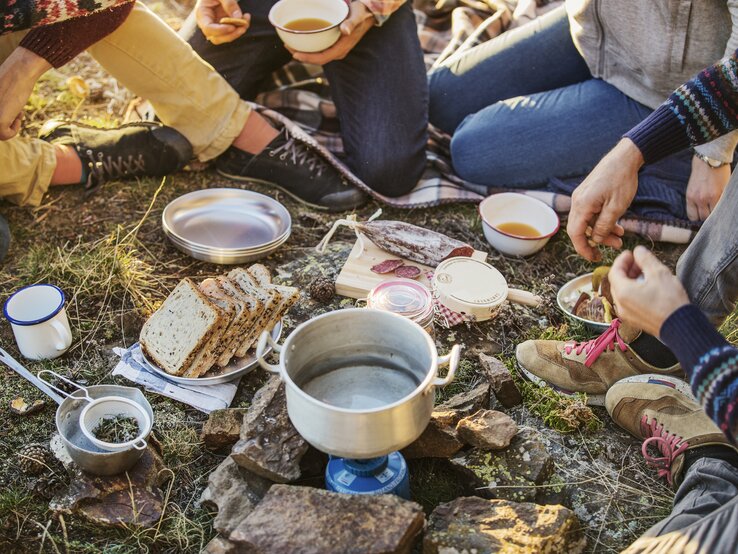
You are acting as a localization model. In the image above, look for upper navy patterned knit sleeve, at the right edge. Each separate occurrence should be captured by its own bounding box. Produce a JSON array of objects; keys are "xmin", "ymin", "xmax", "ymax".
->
[{"xmin": 625, "ymin": 51, "xmax": 738, "ymax": 163}]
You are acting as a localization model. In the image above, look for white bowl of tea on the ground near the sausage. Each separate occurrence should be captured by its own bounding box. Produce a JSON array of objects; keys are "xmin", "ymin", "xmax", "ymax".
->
[{"xmin": 479, "ymin": 192, "xmax": 561, "ymax": 256}]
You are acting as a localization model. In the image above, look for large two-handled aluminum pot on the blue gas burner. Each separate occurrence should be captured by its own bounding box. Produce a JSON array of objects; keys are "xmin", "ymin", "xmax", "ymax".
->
[{"xmin": 256, "ymin": 308, "xmax": 460, "ymax": 459}]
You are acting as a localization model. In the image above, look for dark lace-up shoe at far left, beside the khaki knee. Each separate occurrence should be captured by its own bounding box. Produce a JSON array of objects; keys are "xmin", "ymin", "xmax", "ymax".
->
[{"xmin": 39, "ymin": 120, "xmax": 192, "ymax": 192}]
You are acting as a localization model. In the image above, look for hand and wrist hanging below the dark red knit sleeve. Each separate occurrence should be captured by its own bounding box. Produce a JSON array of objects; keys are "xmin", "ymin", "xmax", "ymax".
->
[{"xmin": 0, "ymin": 47, "xmax": 51, "ymax": 140}]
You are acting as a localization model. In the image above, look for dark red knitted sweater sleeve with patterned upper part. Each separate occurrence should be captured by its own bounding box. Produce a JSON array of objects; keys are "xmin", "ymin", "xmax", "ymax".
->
[{"xmin": 0, "ymin": 0, "xmax": 134, "ymax": 67}]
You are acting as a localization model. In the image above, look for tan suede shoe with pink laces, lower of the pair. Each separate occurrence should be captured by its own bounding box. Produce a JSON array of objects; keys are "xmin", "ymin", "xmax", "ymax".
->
[{"xmin": 605, "ymin": 375, "xmax": 733, "ymax": 485}]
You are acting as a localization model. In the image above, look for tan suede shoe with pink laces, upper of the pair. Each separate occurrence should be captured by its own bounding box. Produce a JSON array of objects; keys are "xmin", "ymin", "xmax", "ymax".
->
[{"xmin": 515, "ymin": 319, "xmax": 683, "ymax": 406}]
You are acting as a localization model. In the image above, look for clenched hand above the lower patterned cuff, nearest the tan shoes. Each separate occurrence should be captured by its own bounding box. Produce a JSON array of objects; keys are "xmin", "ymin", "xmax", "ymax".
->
[{"xmin": 607, "ymin": 246, "xmax": 689, "ymax": 337}]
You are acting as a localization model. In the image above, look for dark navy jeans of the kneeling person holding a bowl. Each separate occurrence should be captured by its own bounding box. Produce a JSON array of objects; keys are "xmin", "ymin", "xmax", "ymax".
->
[{"xmin": 180, "ymin": 0, "xmax": 428, "ymax": 196}]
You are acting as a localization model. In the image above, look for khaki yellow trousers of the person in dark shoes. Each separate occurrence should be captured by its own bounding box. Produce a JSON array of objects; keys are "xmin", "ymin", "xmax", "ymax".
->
[{"xmin": 0, "ymin": 2, "xmax": 250, "ymax": 206}]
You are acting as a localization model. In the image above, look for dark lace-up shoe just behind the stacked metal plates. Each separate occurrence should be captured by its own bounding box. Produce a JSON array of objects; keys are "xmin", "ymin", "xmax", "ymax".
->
[{"xmin": 215, "ymin": 129, "xmax": 368, "ymax": 212}]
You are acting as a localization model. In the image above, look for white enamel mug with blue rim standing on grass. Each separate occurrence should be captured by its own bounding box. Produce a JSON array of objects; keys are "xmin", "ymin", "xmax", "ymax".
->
[{"xmin": 3, "ymin": 284, "xmax": 72, "ymax": 360}]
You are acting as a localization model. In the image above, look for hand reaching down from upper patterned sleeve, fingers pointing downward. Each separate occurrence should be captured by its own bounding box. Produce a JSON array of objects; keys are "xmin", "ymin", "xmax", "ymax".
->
[{"xmin": 566, "ymin": 139, "xmax": 643, "ymax": 261}]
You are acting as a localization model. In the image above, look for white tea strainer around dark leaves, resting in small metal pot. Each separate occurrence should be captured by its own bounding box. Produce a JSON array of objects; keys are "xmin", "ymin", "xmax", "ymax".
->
[{"xmin": 79, "ymin": 396, "xmax": 153, "ymax": 452}]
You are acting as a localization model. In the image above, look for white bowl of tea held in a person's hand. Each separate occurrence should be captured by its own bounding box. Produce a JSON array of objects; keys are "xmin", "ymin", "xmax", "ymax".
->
[{"xmin": 269, "ymin": 0, "xmax": 349, "ymax": 52}]
